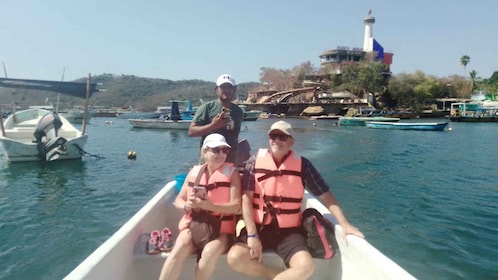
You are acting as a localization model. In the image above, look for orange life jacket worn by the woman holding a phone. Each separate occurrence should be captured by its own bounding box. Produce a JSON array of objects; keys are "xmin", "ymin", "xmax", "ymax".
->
[{"xmin": 178, "ymin": 162, "xmax": 236, "ymax": 234}]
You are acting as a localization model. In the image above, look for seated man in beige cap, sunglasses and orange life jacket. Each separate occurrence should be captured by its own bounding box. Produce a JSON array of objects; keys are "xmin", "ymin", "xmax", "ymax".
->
[{"xmin": 227, "ymin": 121, "xmax": 364, "ymax": 279}]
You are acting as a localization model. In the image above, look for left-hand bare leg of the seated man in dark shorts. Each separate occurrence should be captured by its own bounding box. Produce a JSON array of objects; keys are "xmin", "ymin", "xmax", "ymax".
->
[{"xmin": 227, "ymin": 243, "xmax": 280, "ymax": 279}]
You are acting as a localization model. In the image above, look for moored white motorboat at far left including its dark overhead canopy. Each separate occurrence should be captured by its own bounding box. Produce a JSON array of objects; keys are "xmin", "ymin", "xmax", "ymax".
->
[{"xmin": 0, "ymin": 75, "xmax": 98, "ymax": 162}]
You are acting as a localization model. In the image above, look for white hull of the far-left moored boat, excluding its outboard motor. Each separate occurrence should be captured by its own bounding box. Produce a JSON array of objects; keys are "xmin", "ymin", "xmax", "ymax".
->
[{"xmin": 0, "ymin": 109, "xmax": 87, "ymax": 162}]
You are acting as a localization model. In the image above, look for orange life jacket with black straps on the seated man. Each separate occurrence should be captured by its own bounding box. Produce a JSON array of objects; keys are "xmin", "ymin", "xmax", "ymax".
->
[{"xmin": 253, "ymin": 149, "xmax": 304, "ymax": 228}]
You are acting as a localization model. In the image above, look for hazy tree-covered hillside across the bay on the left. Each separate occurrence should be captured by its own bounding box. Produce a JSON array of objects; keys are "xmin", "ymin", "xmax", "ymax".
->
[{"xmin": 0, "ymin": 74, "xmax": 258, "ymax": 111}]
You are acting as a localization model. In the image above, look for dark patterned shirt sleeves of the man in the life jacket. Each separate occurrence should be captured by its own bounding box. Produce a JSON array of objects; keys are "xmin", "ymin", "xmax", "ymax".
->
[{"xmin": 242, "ymin": 151, "xmax": 329, "ymax": 196}]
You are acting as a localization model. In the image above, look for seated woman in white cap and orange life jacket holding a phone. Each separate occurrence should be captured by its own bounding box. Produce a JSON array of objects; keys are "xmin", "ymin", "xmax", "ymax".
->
[{"xmin": 159, "ymin": 133, "xmax": 241, "ymax": 279}]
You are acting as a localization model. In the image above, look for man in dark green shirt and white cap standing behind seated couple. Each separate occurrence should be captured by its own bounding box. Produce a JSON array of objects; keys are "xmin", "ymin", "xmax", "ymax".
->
[{"xmin": 188, "ymin": 74, "xmax": 244, "ymax": 164}]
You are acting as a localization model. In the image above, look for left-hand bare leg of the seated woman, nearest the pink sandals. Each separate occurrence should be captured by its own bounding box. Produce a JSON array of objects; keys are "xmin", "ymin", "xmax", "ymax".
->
[{"xmin": 159, "ymin": 229, "xmax": 195, "ymax": 280}]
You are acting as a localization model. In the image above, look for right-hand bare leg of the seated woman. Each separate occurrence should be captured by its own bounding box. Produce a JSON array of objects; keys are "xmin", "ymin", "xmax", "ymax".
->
[{"xmin": 194, "ymin": 234, "xmax": 228, "ymax": 280}]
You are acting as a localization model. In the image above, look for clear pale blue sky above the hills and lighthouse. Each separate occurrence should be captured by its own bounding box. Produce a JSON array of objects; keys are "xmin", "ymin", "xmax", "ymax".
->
[{"xmin": 0, "ymin": 0, "xmax": 498, "ymax": 83}]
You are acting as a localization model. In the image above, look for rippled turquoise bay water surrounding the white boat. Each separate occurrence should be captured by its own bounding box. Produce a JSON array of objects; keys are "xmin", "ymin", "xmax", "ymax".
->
[{"xmin": 0, "ymin": 118, "xmax": 498, "ymax": 279}]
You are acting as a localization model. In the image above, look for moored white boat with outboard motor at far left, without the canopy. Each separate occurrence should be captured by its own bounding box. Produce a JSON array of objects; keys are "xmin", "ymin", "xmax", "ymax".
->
[{"xmin": 0, "ymin": 109, "xmax": 87, "ymax": 162}]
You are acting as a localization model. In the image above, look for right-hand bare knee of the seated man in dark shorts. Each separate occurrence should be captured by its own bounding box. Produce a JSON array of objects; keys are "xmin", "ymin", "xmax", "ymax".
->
[{"xmin": 273, "ymin": 251, "xmax": 315, "ymax": 280}]
